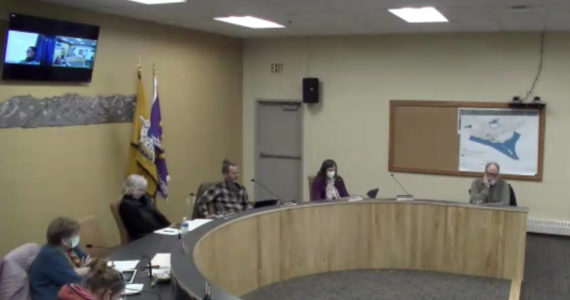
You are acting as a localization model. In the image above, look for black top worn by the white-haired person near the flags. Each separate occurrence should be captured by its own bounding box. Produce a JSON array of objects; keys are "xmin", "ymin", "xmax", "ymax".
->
[{"xmin": 119, "ymin": 194, "xmax": 170, "ymax": 240}]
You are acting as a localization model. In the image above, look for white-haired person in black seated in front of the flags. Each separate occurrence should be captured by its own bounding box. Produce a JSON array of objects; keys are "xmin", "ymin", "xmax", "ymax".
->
[{"xmin": 119, "ymin": 174, "xmax": 170, "ymax": 240}]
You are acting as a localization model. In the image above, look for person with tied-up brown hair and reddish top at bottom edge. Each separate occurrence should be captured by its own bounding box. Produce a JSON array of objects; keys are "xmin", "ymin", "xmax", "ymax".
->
[{"xmin": 58, "ymin": 258, "xmax": 125, "ymax": 300}]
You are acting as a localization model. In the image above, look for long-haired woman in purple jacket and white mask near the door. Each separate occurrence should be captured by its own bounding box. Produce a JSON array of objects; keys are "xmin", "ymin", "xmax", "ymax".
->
[{"xmin": 311, "ymin": 159, "xmax": 348, "ymax": 201}]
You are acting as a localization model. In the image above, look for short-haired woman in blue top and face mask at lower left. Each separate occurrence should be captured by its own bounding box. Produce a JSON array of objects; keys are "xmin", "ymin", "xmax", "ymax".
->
[{"xmin": 30, "ymin": 217, "xmax": 90, "ymax": 300}]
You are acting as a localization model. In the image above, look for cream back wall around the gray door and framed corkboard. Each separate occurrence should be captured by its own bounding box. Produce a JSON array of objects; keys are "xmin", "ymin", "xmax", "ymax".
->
[{"xmin": 243, "ymin": 33, "xmax": 570, "ymax": 220}]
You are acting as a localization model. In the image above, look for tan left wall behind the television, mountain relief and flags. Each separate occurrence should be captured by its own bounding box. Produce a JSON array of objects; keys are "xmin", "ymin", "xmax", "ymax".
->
[{"xmin": 0, "ymin": 0, "xmax": 242, "ymax": 255}]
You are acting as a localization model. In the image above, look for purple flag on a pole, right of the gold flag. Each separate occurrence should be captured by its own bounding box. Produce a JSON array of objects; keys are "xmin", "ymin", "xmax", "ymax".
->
[{"xmin": 150, "ymin": 71, "xmax": 170, "ymax": 199}]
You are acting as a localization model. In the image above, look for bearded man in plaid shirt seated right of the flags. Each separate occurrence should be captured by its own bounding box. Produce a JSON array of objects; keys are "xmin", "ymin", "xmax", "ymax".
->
[{"xmin": 198, "ymin": 159, "xmax": 252, "ymax": 218}]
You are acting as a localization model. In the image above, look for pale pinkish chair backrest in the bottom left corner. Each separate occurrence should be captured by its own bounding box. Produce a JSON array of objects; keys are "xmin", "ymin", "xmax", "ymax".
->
[{"xmin": 0, "ymin": 243, "xmax": 40, "ymax": 300}]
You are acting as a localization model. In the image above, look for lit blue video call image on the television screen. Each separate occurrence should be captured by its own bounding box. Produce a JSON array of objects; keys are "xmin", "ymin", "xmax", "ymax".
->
[{"xmin": 4, "ymin": 30, "xmax": 97, "ymax": 69}]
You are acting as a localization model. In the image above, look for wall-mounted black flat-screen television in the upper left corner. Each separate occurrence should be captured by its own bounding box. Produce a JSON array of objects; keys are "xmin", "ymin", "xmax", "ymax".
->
[{"xmin": 2, "ymin": 13, "xmax": 99, "ymax": 82}]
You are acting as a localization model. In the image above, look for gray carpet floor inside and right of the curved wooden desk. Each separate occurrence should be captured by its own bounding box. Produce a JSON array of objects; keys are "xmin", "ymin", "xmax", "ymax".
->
[{"xmin": 242, "ymin": 234, "xmax": 570, "ymax": 300}]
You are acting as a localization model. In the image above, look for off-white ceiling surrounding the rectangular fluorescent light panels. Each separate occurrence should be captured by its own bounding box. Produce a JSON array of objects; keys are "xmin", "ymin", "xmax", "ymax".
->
[{"xmin": 37, "ymin": 0, "xmax": 570, "ymax": 37}]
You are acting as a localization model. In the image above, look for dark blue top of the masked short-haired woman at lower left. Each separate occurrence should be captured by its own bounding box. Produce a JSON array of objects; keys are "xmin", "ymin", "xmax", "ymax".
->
[{"xmin": 30, "ymin": 244, "xmax": 86, "ymax": 300}]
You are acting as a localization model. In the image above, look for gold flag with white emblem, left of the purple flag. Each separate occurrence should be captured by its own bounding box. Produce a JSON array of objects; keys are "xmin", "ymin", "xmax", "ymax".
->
[{"xmin": 127, "ymin": 67, "xmax": 157, "ymax": 196}]
